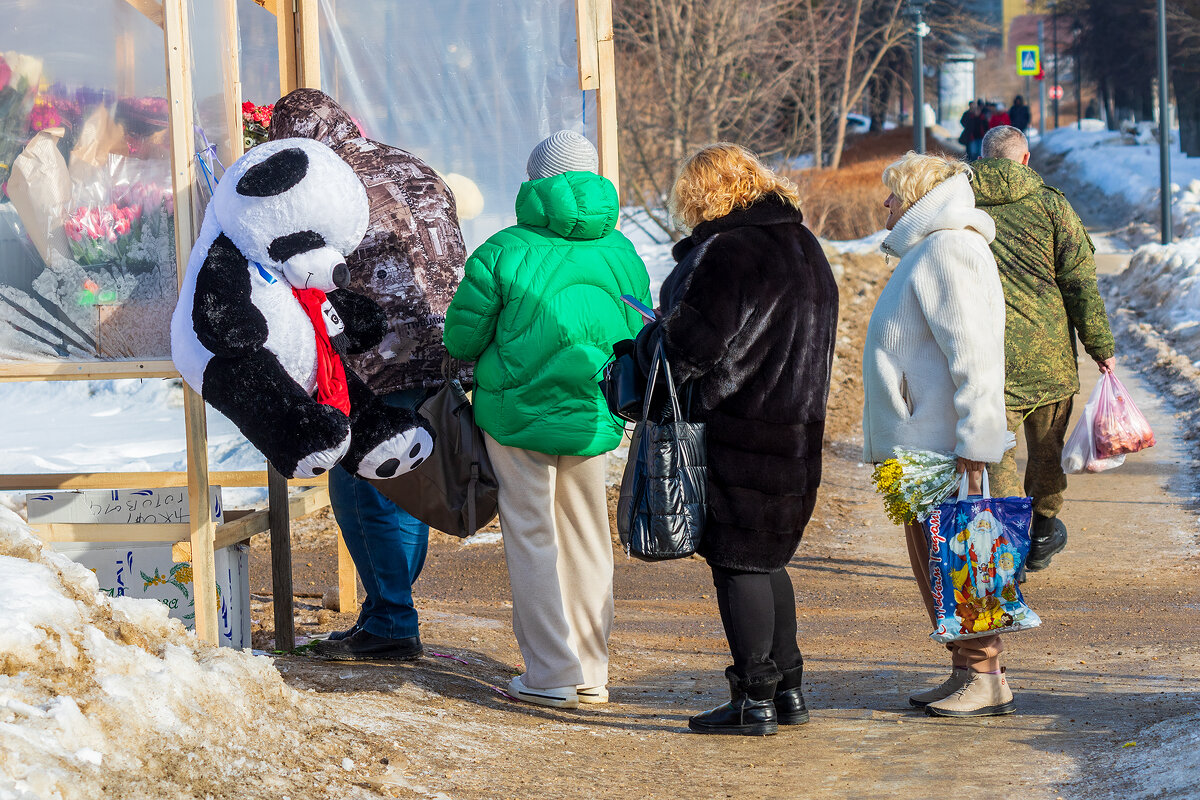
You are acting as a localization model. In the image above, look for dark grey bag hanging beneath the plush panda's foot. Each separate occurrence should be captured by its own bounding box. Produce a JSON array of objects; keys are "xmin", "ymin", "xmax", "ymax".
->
[{"xmin": 371, "ymin": 361, "xmax": 499, "ymax": 537}]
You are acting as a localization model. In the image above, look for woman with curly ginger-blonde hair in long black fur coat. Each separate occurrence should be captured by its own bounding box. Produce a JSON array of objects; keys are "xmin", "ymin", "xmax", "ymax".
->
[{"xmin": 637, "ymin": 144, "xmax": 838, "ymax": 735}]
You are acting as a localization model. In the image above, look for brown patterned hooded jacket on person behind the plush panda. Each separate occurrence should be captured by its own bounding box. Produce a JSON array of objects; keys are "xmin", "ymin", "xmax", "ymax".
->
[{"xmin": 270, "ymin": 89, "xmax": 470, "ymax": 395}]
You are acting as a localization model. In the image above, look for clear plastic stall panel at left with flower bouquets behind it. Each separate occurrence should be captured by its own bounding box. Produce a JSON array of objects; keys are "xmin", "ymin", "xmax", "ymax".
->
[{"xmin": 0, "ymin": 0, "xmax": 176, "ymax": 361}]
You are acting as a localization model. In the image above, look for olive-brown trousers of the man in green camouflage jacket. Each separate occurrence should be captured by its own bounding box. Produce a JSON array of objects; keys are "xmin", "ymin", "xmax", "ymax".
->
[{"xmin": 988, "ymin": 397, "xmax": 1075, "ymax": 517}]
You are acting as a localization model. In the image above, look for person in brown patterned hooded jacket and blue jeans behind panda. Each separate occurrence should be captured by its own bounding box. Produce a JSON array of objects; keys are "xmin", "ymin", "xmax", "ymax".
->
[{"xmin": 270, "ymin": 89, "xmax": 469, "ymax": 661}]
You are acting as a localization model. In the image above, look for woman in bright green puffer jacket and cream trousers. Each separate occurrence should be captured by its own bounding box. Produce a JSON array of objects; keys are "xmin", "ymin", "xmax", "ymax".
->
[{"xmin": 445, "ymin": 131, "xmax": 649, "ymax": 708}]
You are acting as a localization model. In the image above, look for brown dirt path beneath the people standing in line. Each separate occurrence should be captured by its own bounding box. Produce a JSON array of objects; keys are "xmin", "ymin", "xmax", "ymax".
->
[{"xmin": 246, "ymin": 225, "xmax": 1200, "ymax": 800}]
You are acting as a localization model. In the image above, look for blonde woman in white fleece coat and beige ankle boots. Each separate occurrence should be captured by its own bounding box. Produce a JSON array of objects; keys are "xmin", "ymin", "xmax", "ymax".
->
[{"xmin": 863, "ymin": 152, "xmax": 1013, "ymax": 716}]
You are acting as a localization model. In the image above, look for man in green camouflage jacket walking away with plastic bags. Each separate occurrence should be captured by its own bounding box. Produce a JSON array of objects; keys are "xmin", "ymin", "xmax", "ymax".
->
[{"xmin": 972, "ymin": 125, "xmax": 1115, "ymax": 571}]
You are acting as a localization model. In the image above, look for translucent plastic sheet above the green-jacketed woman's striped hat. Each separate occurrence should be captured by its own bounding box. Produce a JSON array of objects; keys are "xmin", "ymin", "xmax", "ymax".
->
[{"xmin": 312, "ymin": 0, "xmax": 595, "ymax": 248}]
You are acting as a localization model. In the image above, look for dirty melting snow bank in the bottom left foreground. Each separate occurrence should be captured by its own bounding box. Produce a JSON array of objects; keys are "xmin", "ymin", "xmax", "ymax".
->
[{"xmin": 0, "ymin": 507, "xmax": 377, "ymax": 800}]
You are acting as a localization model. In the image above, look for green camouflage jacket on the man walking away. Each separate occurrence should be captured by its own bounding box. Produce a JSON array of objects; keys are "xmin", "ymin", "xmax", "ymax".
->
[{"xmin": 971, "ymin": 158, "xmax": 1114, "ymax": 409}]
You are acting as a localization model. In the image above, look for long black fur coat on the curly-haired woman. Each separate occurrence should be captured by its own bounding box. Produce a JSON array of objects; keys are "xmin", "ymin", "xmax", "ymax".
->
[{"xmin": 637, "ymin": 196, "xmax": 838, "ymax": 572}]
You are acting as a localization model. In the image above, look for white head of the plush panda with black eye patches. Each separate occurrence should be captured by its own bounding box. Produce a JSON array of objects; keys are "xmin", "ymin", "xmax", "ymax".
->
[{"xmin": 211, "ymin": 139, "xmax": 368, "ymax": 291}]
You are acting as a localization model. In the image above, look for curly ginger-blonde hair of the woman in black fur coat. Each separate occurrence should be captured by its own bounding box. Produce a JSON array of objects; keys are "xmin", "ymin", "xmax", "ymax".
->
[{"xmin": 668, "ymin": 142, "xmax": 800, "ymax": 229}]
